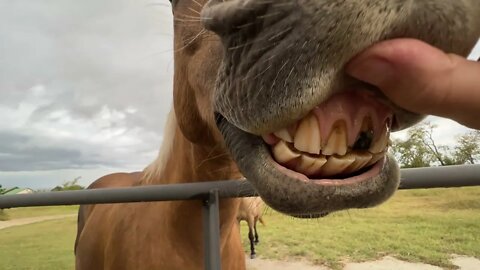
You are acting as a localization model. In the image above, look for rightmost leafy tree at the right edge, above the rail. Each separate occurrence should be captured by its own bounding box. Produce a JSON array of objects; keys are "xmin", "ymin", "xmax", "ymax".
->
[{"xmin": 453, "ymin": 130, "xmax": 480, "ymax": 164}]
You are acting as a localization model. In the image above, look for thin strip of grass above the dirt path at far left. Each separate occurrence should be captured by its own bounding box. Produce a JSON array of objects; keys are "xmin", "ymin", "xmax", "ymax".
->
[{"xmin": 4, "ymin": 205, "xmax": 78, "ymax": 219}]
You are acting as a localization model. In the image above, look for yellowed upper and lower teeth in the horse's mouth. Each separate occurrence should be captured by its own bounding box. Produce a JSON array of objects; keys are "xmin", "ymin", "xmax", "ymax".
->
[{"xmin": 272, "ymin": 114, "xmax": 389, "ymax": 177}]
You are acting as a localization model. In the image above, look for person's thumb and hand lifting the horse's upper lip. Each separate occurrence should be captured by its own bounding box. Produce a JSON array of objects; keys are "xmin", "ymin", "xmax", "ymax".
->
[{"xmin": 346, "ymin": 39, "xmax": 480, "ymax": 129}]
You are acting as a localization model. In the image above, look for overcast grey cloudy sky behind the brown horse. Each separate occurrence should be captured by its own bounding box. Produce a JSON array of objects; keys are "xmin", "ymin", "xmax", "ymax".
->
[{"xmin": 0, "ymin": 0, "xmax": 480, "ymax": 188}]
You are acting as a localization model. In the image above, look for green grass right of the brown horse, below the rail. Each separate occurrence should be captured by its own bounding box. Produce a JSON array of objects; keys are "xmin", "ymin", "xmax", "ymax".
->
[{"xmin": 242, "ymin": 187, "xmax": 480, "ymax": 269}]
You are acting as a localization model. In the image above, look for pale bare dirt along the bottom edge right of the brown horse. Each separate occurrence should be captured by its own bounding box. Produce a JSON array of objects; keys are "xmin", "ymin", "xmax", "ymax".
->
[{"xmin": 247, "ymin": 255, "xmax": 480, "ymax": 270}]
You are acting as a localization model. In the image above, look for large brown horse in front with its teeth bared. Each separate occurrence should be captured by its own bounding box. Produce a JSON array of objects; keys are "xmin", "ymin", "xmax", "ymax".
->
[{"xmin": 75, "ymin": 0, "xmax": 480, "ymax": 270}]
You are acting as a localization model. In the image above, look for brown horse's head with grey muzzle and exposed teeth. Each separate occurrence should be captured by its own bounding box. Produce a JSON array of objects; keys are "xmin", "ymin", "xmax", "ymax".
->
[{"xmin": 172, "ymin": 0, "xmax": 480, "ymax": 217}]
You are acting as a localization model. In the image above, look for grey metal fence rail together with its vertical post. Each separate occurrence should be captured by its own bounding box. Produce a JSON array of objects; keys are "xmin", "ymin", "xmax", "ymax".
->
[{"xmin": 0, "ymin": 165, "xmax": 480, "ymax": 270}]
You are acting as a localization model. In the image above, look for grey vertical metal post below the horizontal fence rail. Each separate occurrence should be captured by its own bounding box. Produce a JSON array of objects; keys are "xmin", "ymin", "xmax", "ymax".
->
[{"xmin": 202, "ymin": 189, "xmax": 221, "ymax": 270}]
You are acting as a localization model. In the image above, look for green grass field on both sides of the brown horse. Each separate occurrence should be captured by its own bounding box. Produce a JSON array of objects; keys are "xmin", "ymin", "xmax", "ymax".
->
[{"xmin": 0, "ymin": 187, "xmax": 480, "ymax": 270}]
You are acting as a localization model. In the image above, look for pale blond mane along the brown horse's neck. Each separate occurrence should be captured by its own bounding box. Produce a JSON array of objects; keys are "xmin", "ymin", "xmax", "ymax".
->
[{"xmin": 143, "ymin": 108, "xmax": 177, "ymax": 184}]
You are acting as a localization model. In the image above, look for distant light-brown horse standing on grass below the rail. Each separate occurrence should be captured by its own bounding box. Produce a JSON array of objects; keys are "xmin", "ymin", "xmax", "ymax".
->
[{"xmin": 237, "ymin": 197, "xmax": 265, "ymax": 259}]
